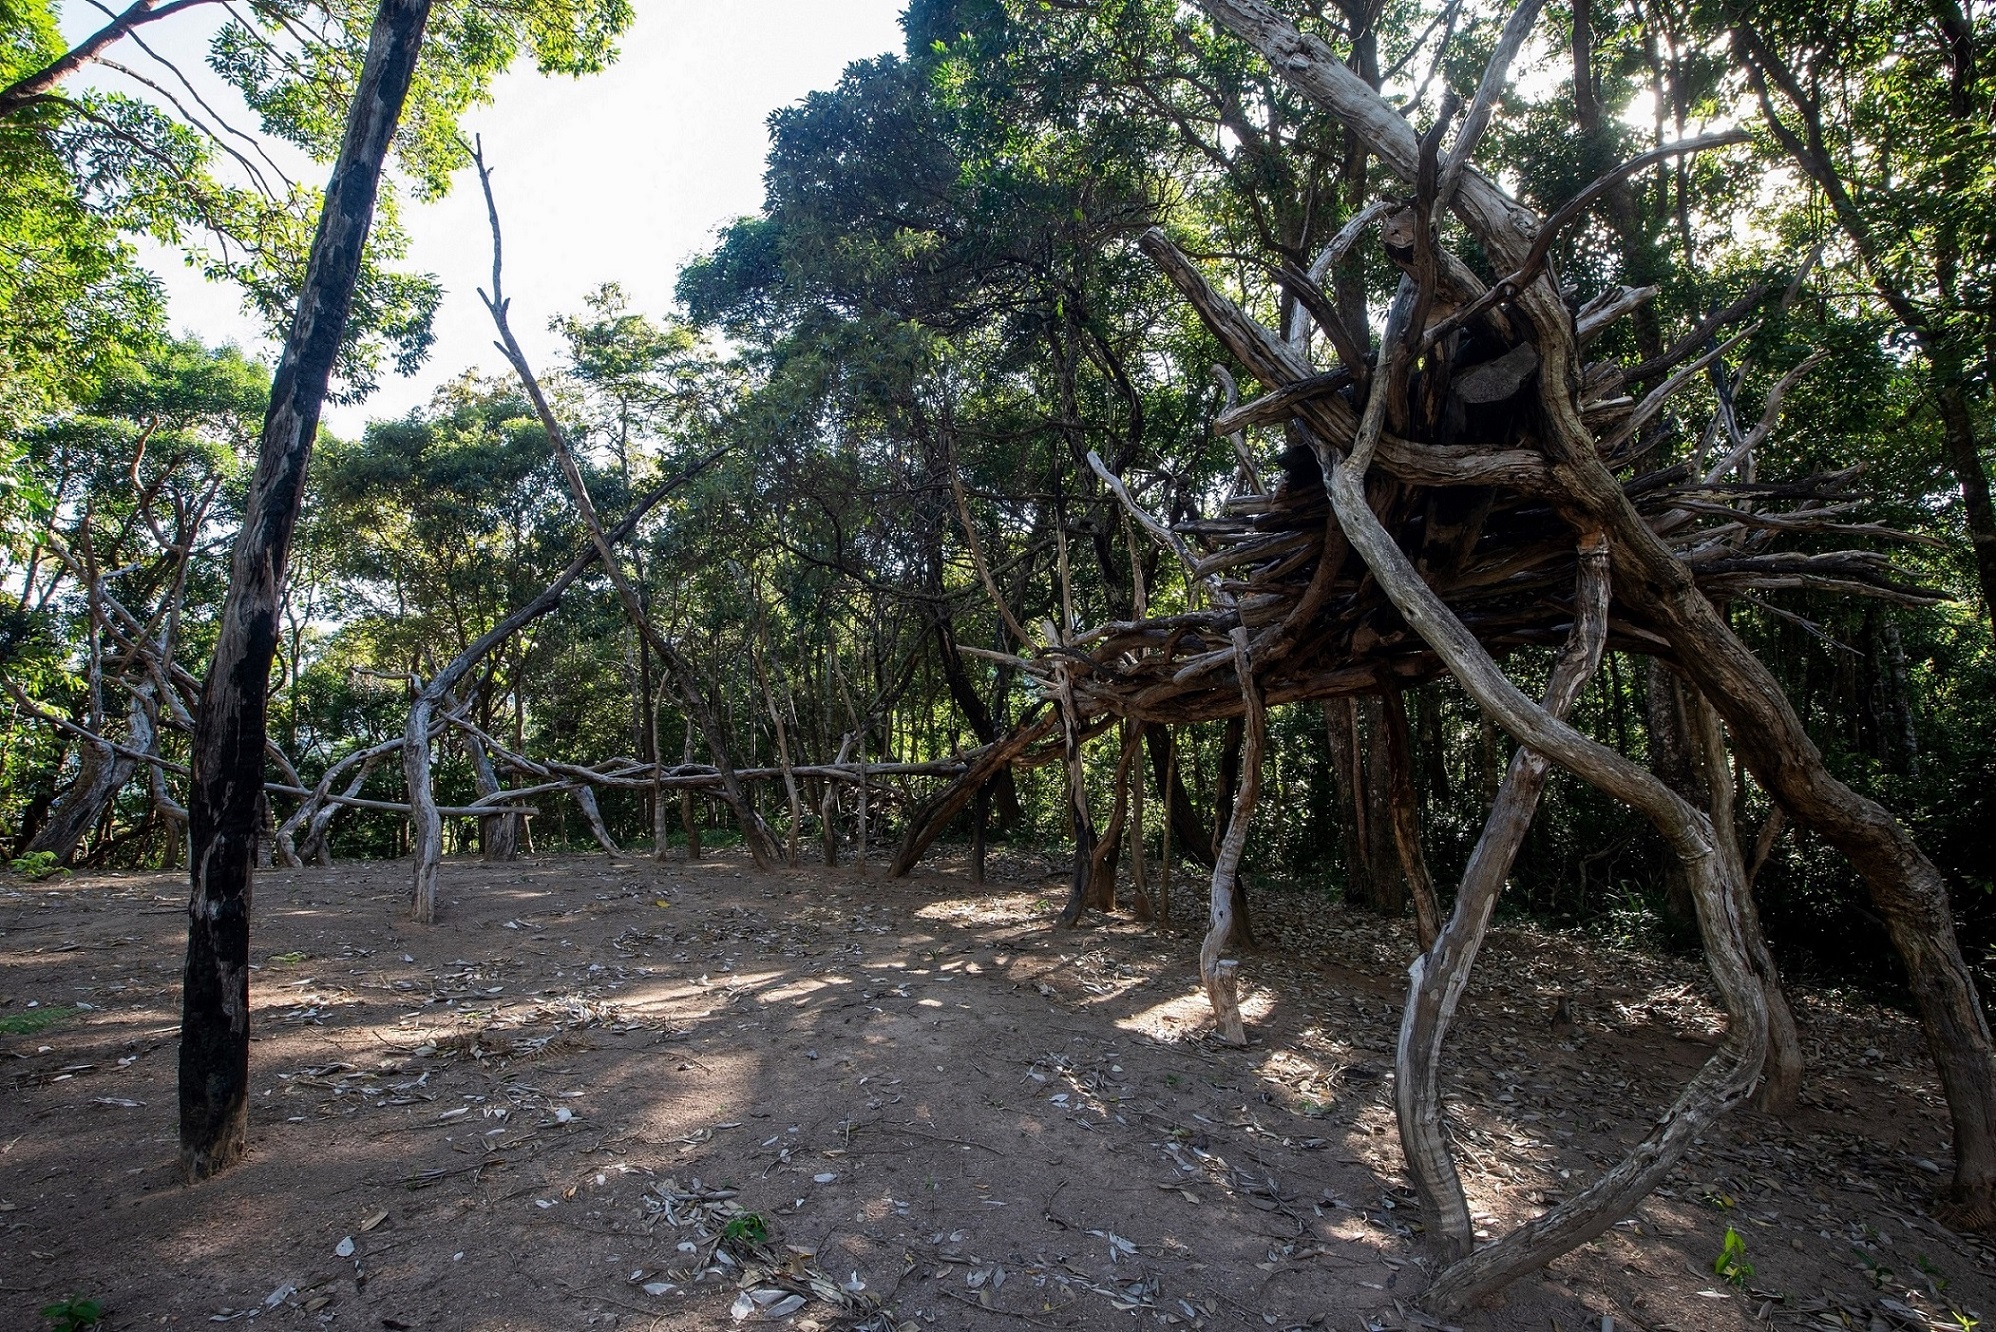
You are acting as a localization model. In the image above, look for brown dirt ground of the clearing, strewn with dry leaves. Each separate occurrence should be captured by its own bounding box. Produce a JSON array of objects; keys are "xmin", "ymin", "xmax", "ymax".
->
[{"xmin": 0, "ymin": 855, "xmax": 1996, "ymax": 1332}]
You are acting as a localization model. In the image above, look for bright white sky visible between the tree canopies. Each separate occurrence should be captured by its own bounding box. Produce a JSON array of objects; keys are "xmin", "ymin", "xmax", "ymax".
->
[{"xmin": 95, "ymin": 0, "xmax": 900, "ymax": 435}]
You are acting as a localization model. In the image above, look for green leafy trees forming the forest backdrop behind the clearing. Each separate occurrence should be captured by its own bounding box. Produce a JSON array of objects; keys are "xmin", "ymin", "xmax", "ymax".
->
[{"xmin": 0, "ymin": 0, "xmax": 1996, "ymax": 1010}]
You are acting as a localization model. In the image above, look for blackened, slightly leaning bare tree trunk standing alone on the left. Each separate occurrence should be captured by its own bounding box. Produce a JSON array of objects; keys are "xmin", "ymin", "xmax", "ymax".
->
[{"xmin": 180, "ymin": 0, "xmax": 429, "ymax": 1180}]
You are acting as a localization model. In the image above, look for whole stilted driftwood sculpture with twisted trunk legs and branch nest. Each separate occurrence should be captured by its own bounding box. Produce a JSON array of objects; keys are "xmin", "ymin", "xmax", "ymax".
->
[{"xmin": 896, "ymin": 0, "xmax": 1996, "ymax": 1312}]
